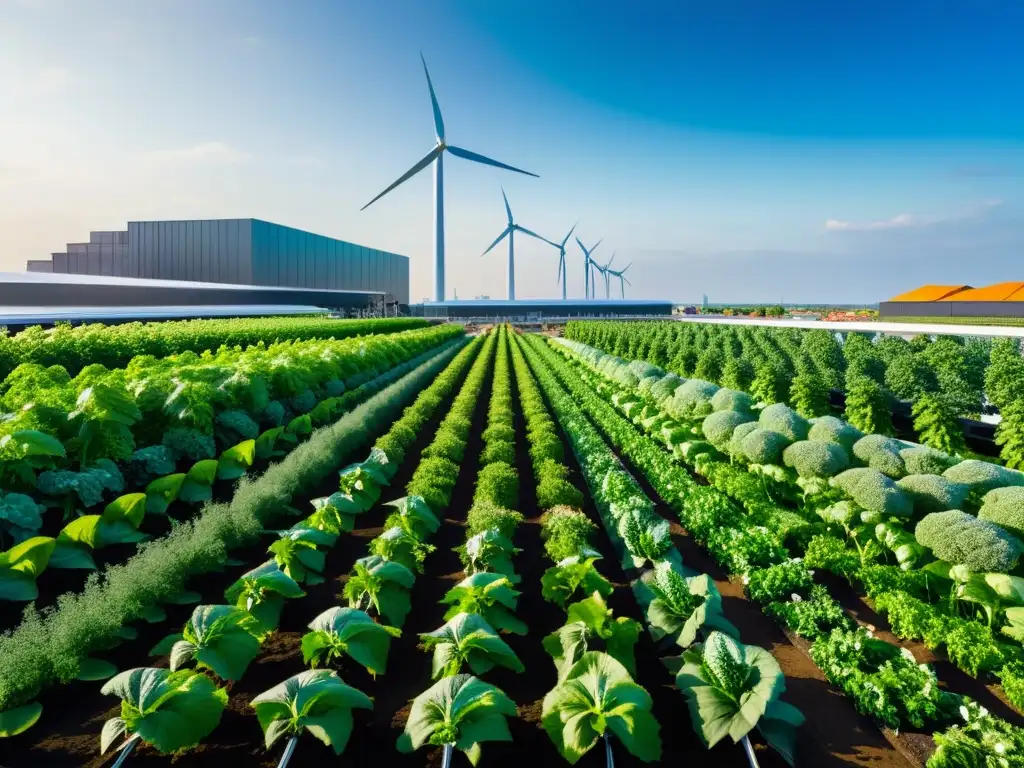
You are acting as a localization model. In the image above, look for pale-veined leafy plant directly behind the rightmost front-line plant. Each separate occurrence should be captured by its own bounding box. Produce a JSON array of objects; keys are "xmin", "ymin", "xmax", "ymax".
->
[{"xmin": 633, "ymin": 560, "xmax": 739, "ymax": 648}]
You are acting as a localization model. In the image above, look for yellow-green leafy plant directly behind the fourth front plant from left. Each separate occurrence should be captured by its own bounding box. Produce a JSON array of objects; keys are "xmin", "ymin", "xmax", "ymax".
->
[{"xmin": 544, "ymin": 592, "xmax": 640, "ymax": 680}]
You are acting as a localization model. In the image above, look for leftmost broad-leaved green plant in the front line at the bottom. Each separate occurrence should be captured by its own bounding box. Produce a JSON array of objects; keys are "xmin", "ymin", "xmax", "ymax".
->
[{"xmin": 99, "ymin": 667, "xmax": 227, "ymax": 754}]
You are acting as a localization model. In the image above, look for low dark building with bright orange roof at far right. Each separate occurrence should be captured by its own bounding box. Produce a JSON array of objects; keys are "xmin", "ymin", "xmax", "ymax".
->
[{"xmin": 879, "ymin": 283, "xmax": 1024, "ymax": 319}]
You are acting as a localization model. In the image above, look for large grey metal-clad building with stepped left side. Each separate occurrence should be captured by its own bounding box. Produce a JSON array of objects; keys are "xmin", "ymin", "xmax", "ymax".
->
[{"xmin": 27, "ymin": 219, "xmax": 409, "ymax": 304}]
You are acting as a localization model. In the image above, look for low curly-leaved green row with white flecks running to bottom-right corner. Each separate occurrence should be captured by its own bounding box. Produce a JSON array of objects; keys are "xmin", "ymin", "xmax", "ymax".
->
[{"xmin": 546, "ymin": 333, "xmax": 1022, "ymax": 765}]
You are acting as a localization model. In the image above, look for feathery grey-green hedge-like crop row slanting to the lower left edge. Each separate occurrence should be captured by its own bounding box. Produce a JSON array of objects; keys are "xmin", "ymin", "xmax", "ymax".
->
[{"xmin": 0, "ymin": 337, "xmax": 468, "ymax": 733}]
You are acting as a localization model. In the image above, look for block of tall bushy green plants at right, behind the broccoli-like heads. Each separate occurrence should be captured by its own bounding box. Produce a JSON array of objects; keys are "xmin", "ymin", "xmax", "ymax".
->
[{"xmin": 566, "ymin": 322, "xmax": 1024, "ymax": 467}]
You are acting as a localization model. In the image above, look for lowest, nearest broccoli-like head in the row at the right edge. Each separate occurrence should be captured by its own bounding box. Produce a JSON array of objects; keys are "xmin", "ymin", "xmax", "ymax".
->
[{"xmin": 914, "ymin": 510, "xmax": 1024, "ymax": 573}]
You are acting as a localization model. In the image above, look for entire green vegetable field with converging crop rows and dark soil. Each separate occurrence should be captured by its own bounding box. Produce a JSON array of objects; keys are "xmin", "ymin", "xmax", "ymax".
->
[{"xmin": 0, "ymin": 318, "xmax": 1024, "ymax": 768}]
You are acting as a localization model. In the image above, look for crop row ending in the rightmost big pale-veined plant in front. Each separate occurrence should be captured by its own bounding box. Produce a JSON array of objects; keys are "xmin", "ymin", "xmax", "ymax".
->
[{"xmin": 524, "ymin": 338, "xmax": 804, "ymax": 763}]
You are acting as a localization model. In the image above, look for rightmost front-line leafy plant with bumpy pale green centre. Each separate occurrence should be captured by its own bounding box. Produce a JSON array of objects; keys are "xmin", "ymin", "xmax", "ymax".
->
[{"xmin": 676, "ymin": 632, "xmax": 804, "ymax": 765}]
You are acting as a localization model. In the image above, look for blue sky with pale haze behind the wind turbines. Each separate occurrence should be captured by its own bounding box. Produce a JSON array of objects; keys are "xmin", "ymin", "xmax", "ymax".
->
[{"xmin": 0, "ymin": 0, "xmax": 1024, "ymax": 301}]
